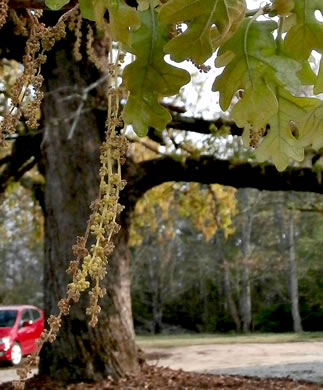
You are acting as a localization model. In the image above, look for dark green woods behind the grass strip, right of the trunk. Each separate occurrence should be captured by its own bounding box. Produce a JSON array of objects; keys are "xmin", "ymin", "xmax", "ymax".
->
[{"xmin": 132, "ymin": 190, "xmax": 322, "ymax": 333}]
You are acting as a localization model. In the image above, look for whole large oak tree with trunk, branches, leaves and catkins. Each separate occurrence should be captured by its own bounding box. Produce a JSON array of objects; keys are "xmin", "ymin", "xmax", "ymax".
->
[{"xmin": 0, "ymin": 0, "xmax": 323, "ymax": 381}]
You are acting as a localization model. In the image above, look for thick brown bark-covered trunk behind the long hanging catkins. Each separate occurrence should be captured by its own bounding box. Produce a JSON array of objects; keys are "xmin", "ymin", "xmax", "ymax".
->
[{"xmin": 40, "ymin": 36, "xmax": 139, "ymax": 381}]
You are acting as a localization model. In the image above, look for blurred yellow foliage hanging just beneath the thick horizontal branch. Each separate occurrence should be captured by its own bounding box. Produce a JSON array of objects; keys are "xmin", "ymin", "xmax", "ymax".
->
[{"xmin": 130, "ymin": 182, "xmax": 237, "ymax": 246}]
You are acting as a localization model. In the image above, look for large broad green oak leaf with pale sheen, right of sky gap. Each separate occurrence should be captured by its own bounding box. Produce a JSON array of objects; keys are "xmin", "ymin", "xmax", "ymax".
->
[{"xmin": 213, "ymin": 18, "xmax": 302, "ymax": 133}]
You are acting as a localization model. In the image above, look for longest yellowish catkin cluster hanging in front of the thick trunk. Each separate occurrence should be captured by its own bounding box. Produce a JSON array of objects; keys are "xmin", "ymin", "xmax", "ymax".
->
[{"xmin": 67, "ymin": 47, "xmax": 128, "ymax": 327}]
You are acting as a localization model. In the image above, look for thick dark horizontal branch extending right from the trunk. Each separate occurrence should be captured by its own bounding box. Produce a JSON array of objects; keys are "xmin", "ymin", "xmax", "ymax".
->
[{"xmin": 123, "ymin": 155, "xmax": 323, "ymax": 210}]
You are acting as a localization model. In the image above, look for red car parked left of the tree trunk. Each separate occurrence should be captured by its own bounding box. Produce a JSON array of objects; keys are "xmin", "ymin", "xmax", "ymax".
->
[{"xmin": 0, "ymin": 305, "xmax": 44, "ymax": 365}]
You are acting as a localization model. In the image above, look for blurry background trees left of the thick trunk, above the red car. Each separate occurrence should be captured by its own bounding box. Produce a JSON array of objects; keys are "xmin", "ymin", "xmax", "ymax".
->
[{"xmin": 0, "ymin": 184, "xmax": 43, "ymax": 306}]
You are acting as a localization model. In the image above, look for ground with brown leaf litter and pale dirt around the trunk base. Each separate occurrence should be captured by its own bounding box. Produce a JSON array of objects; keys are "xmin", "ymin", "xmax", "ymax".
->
[{"xmin": 0, "ymin": 342, "xmax": 323, "ymax": 390}]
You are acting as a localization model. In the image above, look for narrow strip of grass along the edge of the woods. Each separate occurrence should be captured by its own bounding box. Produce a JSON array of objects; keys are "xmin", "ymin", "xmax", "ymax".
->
[{"xmin": 137, "ymin": 332, "xmax": 323, "ymax": 348}]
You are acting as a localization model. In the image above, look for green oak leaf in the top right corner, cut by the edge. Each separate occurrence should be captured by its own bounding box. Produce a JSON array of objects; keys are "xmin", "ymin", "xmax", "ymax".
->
[{"xmin": 284, "ymin": 0, "xmax": 323, "ymax": 59}]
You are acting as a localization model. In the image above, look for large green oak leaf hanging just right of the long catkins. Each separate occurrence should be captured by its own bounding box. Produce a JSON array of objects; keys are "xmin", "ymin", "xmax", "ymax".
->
[{"xmin": 122, "ymin": 9, "xmax": 190, "ymax": 136}]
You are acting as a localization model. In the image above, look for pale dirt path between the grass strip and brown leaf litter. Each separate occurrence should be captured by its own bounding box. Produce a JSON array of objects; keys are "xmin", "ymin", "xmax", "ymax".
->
[{"xmin": 146, "ymin": 342, "xmax": 323, "ymax": 388}]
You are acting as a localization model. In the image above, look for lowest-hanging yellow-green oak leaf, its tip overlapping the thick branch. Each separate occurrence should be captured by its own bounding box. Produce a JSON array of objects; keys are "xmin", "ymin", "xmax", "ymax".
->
[{"xmin": 256, "ymin": 88, "xmax": 320, "ymax": 171}]
